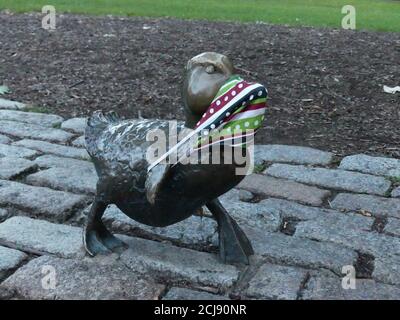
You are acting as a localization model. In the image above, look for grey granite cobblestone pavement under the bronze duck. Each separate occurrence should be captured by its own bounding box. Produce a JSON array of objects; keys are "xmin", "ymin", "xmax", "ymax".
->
[{"xmin": 0, "ymin": 99, "xmax": 400, "ymax": 300}]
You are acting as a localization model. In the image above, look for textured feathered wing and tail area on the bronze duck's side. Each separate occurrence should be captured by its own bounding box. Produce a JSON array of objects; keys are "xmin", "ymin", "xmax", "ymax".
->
[{"xmin": 85, "ymin": 111, "xmax": 185, "ymax": 203}]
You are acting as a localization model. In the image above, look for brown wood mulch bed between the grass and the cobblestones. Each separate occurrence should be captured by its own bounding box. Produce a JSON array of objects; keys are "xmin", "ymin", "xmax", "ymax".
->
[{"xmin": 0, "ymin": 13, "xmax": 400, "ymax": 157}]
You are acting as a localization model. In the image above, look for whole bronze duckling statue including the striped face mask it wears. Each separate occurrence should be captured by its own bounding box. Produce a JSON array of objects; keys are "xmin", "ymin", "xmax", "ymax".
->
[{"xmin": 83, "ymin": 52, "xmax": 267, "ymax": 264}]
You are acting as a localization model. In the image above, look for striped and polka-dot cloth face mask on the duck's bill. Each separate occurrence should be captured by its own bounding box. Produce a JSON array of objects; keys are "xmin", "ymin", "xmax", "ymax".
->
[{"xmin": 148, "ymin": 76, "xmax": 268, "ymax": 171}]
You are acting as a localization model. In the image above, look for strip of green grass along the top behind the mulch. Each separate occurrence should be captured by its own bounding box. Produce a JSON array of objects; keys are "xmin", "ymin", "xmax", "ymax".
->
[{"xmin": 0, "ymin": 0, "xmax": 400, "ymax": 32}]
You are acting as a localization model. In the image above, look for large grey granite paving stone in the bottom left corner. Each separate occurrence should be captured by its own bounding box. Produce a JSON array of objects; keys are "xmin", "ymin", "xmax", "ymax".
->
[{"xmin": 0, "ymin": 256, "xmax": 165, "ymax": 300}]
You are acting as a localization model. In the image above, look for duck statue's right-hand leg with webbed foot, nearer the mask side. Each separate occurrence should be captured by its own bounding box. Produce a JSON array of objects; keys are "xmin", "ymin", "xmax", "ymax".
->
[{"xmin": 207, "ymin": 199, "xmax": 254, "ymax": 264}]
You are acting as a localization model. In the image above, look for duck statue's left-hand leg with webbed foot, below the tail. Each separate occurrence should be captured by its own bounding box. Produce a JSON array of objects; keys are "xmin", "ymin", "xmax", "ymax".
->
[{"xmin": 83, "ymin": 197, "xmax": 126, "ymax": 256}]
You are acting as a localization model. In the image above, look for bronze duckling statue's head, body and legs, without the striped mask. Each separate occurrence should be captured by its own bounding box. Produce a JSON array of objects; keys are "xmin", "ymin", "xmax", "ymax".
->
[{"xmin": 83, "ymin": 52, "xmax": 266, "ymax": 264}]
